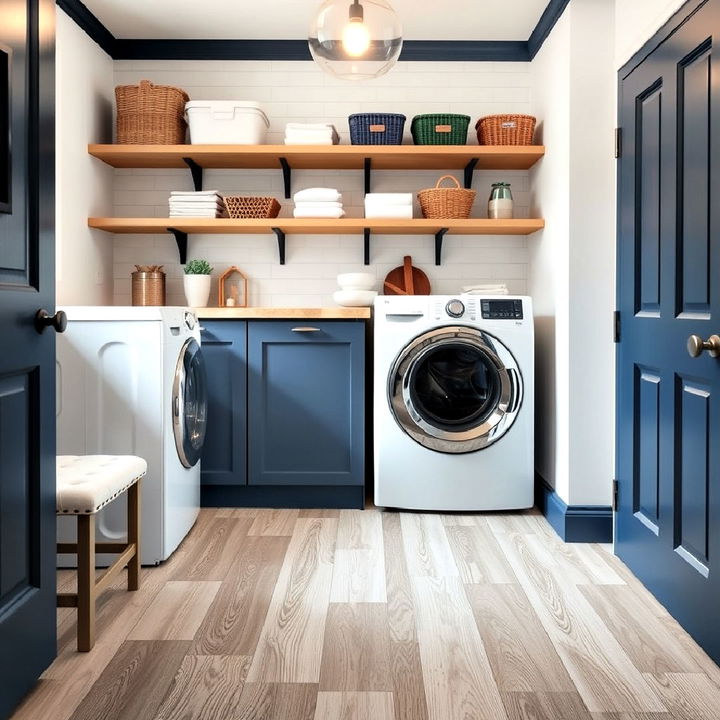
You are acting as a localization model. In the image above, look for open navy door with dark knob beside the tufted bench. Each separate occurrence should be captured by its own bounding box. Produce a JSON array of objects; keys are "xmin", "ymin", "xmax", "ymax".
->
[{"xmin": 0, "ymin": 0, "xmax": 56, "ymax": 718}]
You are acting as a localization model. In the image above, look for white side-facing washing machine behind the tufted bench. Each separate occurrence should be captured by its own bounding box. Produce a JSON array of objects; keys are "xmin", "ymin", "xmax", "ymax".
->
[{"xmin": 57, "ymin": 307, "xmax": 207, "ymax": 567}]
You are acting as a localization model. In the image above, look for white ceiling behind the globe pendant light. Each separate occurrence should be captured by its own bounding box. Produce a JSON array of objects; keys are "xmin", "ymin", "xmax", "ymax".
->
[{"xmin": 84, "ymin": 0, "xmax": 548, "ymax": 40}]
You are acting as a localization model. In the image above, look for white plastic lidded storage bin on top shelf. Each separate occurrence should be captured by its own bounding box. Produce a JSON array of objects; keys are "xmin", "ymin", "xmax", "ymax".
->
[{"xmin": 185, "ymin": 100, "xmax": 270, "ymax": 145}]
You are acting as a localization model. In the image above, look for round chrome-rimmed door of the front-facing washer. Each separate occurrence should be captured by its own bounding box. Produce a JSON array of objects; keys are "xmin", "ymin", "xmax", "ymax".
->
[{"xmin": 388, "ymin": 326, "xmax": 523, "ymax": 453}]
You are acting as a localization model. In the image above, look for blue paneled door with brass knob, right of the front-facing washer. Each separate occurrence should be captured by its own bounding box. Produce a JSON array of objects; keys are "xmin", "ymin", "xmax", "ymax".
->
[{"xmin": 616, "ymin": 0, "xmax": 720, "ymax": 660}]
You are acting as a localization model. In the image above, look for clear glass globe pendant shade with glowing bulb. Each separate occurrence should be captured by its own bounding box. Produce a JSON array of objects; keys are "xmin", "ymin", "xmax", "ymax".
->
[{"xmin": 308, "ymin": 0, "xmax": 402, "ymax": 80}]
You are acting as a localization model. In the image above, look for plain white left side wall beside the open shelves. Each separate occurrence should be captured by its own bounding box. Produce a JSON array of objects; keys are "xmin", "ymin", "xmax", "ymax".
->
[{"xmin": 56, "ymin": 10, "xmax": 113, "ymax": 305}]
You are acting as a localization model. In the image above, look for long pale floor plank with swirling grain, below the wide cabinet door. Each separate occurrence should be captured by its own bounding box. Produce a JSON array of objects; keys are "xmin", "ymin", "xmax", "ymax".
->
[{"xmin": 248, "ymin": 518, "xmax": 337, "ymax": 683}]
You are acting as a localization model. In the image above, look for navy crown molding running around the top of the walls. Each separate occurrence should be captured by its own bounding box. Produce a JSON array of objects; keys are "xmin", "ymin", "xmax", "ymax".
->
[{"xmin": 56, "ymin": 0, "xmax": 569, "ymax": 62}]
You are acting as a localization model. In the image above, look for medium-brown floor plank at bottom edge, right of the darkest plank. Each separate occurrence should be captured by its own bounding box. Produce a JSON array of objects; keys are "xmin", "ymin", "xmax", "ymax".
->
[{"xmin": 155, "ymin": 655, "xmax": 251, "ymax": 720}]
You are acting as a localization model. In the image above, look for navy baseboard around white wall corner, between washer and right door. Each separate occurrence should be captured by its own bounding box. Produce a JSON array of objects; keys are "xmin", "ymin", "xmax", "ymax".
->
[{"xmin": 535, "ymin": 475, "xmax": 613, "ymax": 543}]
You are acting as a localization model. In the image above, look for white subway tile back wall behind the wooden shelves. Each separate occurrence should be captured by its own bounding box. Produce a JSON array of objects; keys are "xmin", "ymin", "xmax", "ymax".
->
[{"xmin": 109, "ymin": 60, "xmax": 532, "ymax": 307}]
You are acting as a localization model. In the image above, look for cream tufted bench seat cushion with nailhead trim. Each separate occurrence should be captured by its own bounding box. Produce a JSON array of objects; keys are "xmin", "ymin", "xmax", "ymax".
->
[{"xmin": 56, "ymin": 455, "xmax": 147, "ymax": 515}]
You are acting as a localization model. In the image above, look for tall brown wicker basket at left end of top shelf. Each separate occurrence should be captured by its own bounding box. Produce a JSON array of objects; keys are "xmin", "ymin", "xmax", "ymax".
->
[{"xmin": 115, "ymin": 80, "xmax": 190, "ymax": 145}]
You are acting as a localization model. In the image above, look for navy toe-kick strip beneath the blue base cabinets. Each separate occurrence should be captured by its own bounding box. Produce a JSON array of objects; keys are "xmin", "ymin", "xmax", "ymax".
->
[{"xmin": 200, "ymin": 485, "xmax": 365, "ymax": 510}]
